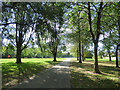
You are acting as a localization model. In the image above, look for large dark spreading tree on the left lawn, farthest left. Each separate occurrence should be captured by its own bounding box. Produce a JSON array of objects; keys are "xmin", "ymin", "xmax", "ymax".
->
[{"xmin": 2, "ymin": 2, "xmax": 34, "ymax": 63}]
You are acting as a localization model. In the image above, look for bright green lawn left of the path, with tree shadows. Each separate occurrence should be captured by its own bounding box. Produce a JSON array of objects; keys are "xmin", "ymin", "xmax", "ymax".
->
[{"xmin": 1, "ymin": 58, "xmax": 65, "ymax": 88}]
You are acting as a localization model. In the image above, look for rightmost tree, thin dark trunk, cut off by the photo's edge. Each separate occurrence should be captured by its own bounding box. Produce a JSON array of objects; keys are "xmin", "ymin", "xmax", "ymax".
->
[{"xmin": 102, "ymin": 2, "xmax": 120, "ymax": 67}]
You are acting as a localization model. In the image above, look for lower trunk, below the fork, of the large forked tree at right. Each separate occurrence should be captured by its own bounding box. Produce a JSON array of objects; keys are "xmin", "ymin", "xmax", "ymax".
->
[{"xmin": 94, "ymin": 43, "xmax": 100, "ymax": 73}]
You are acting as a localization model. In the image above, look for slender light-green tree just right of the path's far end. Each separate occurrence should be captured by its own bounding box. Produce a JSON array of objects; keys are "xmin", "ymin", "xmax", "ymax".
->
[{"xmin": 67, "ymin": 2, "xmax": 90, "ymax": 63}]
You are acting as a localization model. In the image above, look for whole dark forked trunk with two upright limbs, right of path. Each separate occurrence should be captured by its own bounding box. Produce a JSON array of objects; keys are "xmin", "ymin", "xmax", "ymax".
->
[{"xmin": 88, "ymin": 2, "xmax": 103, "ymax": 73}]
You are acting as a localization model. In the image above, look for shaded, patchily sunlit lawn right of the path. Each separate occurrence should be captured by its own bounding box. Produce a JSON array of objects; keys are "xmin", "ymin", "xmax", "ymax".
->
[{"xmin": 71, "ymin": 59, "xmax": 120, "ymax": 88}]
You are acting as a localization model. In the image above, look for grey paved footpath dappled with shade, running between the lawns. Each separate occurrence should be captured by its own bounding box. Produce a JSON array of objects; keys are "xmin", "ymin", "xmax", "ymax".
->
[{"xmin": 13, "ymin": 58, "xmax": 71, "ymax": 88}]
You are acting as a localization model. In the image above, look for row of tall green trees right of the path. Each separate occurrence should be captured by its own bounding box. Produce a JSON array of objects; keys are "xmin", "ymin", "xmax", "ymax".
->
[{"xmin": 66, "ymin": 2, "xmax": 120, "ymax": 73}]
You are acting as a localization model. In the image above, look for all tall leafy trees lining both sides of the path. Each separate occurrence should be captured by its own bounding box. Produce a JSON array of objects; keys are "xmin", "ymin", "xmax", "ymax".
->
[{"xmin": 2, "ymin": 2, "xmax": 120, "ymax": 73}]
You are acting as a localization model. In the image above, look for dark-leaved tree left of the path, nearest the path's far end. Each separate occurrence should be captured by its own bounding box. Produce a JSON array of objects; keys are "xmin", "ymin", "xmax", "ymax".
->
[{"xmin": 29, "ymin": 2, "xmax": 64, "ymax": 61}]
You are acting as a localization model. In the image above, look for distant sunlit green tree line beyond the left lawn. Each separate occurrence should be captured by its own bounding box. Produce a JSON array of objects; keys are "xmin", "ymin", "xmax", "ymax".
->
[{"xmin": 2, "ymin": 44, "xmax": 73, "ymax": 58}]
